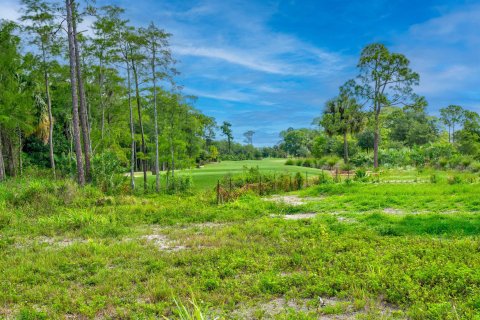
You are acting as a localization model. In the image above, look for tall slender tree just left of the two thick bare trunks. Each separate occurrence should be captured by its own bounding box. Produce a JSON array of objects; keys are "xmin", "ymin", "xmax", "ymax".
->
[{"xmin": 21, "ymin": 0, "xmax": 59, "ymax": 177}]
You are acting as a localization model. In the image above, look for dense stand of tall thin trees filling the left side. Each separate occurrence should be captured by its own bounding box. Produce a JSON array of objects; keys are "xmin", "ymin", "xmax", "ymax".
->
[{"xmin": 0, "ymin": 0, "xmax": 218, "ymax": 190}]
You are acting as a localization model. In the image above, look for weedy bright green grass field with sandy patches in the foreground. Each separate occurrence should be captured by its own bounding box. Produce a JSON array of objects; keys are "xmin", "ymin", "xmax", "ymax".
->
[{"xmin": 0, "ymin": 161, "xmax": 480, "ymax": 319}]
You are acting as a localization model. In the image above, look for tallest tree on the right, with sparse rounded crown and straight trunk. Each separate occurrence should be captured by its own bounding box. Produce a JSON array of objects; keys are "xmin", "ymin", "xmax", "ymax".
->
[{"xmin": 357, "ymin": 43, "xmax": 419, "ymax": 168}]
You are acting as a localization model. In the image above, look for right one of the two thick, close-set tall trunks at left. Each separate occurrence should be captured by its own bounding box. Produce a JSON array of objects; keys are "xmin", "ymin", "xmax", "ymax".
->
[{"xmin": 71, "ymin": 4, "xmax": 92, "ymax": 181}]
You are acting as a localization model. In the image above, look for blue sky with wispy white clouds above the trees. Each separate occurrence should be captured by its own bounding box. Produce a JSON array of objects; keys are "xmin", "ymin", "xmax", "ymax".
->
[{"xmin": 0, "ymin": 0, "xmax": 480, "ymax": 146}]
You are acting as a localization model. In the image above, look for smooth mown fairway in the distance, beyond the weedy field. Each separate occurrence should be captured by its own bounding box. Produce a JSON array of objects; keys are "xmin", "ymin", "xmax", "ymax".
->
[{"xmin": 135, "ymin": 159, "xmax": 321, "ymax": 190}]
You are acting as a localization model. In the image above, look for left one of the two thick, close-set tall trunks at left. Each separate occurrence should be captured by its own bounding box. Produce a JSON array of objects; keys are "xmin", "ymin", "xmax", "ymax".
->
[{"xmin": 65, "ymin": 0, "xmax": 85, "ymax": 186}]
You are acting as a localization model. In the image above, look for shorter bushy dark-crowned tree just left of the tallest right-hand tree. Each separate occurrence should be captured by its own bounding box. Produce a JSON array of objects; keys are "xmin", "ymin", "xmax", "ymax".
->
[{"xmin": 320, "ymin": 80, "xmax": 364, "ymax": 163}]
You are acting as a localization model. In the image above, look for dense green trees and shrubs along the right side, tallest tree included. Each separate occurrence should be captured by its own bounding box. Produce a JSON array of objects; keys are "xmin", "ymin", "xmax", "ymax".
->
[{"xmin": 279, "ymin": 44, "xmax": 480, "ymax": 168}]
